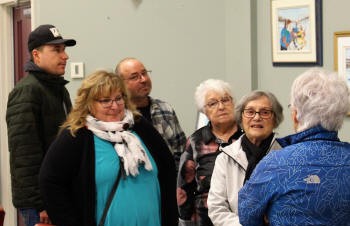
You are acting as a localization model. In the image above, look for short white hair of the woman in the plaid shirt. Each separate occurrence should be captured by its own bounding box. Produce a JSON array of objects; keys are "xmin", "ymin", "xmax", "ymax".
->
[{"xmin": 194, "ymin": 79, "xmax": 234, "ymax": 113}]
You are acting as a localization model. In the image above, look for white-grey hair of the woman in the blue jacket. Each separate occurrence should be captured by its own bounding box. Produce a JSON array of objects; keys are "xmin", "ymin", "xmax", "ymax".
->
[{"xmin": 291, "ymin": 68, "xmax": 350, "ymax": 132}]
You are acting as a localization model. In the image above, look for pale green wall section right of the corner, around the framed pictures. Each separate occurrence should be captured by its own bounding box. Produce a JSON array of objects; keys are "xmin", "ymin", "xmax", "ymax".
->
[{"xmin": 256, "ymin": 0, "xmax": 350, "ymax": 142}]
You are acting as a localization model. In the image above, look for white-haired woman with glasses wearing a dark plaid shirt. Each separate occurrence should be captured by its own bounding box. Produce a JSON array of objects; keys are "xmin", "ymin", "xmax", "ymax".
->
[{"xmin": 177, "ymin": 79, "xmax": 242, "ymax": 226}]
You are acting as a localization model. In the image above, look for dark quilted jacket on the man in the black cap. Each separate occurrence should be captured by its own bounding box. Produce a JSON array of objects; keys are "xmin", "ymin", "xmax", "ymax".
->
[{"xmin": 6, "ymin": 61, "xmax": 72, "ymax": 211}]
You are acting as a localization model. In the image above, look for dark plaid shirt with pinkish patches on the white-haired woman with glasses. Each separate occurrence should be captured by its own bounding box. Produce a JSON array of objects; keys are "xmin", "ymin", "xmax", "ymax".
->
[{"xmin": 177, "ymin": 123, "xmax": 243, "ymax": 226}]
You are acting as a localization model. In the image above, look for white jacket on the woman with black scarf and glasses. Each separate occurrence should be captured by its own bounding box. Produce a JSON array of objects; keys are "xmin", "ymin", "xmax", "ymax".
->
[{"xmin": 207, "ymin": 135, "xmax": 281, "ymax": 226}]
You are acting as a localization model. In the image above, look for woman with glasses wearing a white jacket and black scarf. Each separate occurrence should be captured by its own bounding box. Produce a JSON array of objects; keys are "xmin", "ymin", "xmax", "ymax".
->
[{"xmin": 208, "ymin": 91, "xmax": 283, "ymax": 226}]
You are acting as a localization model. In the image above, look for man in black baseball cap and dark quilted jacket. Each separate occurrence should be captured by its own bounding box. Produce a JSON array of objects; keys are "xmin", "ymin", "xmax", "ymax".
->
[{"xmin": 6, "ymin": 24, "xmax": 76, "ymax": 226}]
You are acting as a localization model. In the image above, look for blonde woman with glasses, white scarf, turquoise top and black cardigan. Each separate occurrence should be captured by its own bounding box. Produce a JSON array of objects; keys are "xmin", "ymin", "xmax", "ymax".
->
[{"xmin": 40, "ymin": 71, "xmax": 178, "ymax": 226}]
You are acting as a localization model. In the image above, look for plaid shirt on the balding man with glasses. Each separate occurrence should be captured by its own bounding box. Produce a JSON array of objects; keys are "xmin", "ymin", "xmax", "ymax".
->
[{"xmin": 150, "ymin": 97, "xmax": 186, "ymax": 162}]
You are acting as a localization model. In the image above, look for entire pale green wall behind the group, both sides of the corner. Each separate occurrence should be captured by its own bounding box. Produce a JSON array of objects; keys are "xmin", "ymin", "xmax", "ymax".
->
[{"xmin": 33, "ymin": 0, "xmax": 350, "ymax": 141}]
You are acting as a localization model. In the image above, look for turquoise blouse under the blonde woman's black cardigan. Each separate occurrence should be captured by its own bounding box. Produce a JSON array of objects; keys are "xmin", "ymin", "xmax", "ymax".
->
[{"xmin": 94, "ymin": 134, "xmax": 161, "ymax": 226}]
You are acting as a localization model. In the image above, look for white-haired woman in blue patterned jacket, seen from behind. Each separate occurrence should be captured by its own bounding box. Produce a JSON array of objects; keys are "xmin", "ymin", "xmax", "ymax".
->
[{"xmin": 238, "ymin": 68, "xmax": 350, "ymax": 226}]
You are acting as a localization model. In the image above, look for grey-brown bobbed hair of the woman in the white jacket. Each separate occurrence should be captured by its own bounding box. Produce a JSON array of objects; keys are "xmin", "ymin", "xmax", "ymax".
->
[{"xmin": 235, "ymin": 90, "xmax": 283, "ymax": 128}]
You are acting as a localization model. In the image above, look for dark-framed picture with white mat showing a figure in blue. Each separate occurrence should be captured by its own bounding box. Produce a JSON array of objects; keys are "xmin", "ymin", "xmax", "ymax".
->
[{"xmin": 271, "ymin": 0, "xmax": 323, "ymax": 66}]
